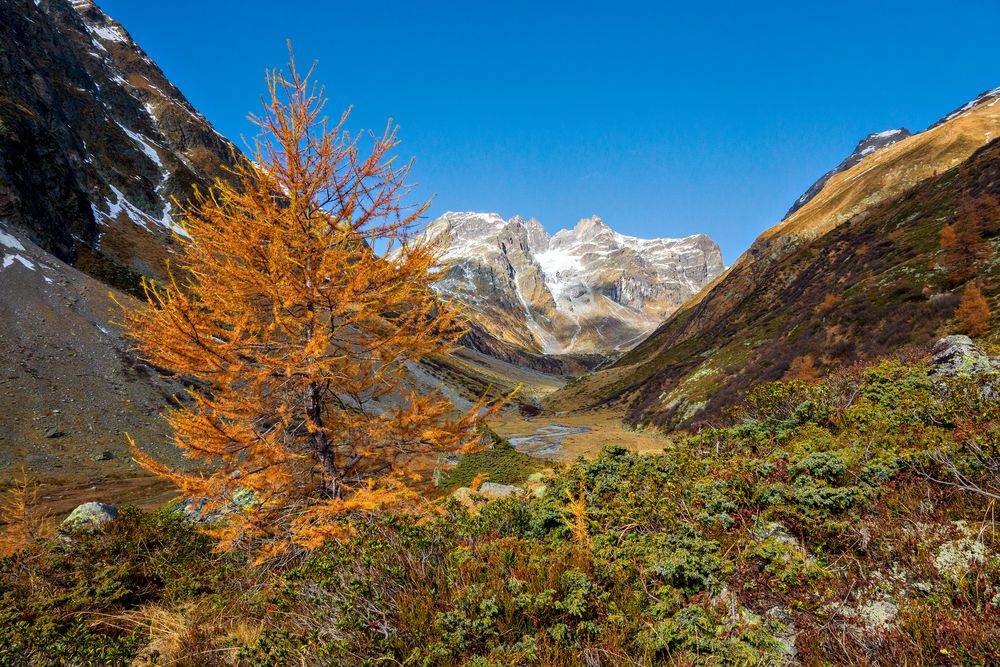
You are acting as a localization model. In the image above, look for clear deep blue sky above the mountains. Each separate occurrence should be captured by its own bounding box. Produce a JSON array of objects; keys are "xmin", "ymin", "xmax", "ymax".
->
[{"xmin": 97, "ymin": 0, "xmax": 1000, "ymax": 263}]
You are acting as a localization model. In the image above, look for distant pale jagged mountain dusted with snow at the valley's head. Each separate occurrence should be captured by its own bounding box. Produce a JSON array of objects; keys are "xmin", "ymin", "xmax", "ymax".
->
[{"xmin": 427, "ymin": 213, "xmax": 725, "ymax": 354}]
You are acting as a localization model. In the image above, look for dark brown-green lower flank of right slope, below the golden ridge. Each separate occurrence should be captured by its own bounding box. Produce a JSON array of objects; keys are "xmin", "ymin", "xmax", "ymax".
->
[{"xmin": 548, "ymin": 142, "xmax": 1000, "ymax": 426}]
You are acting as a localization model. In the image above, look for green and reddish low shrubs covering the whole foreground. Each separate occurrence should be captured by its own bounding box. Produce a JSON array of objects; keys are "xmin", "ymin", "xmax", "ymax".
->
[{"xmin": 0, "ymin": 359, "xmax": 1000, "ymax": 665}]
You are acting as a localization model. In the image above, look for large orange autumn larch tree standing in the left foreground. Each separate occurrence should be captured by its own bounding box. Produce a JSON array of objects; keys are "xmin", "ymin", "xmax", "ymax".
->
[{"xmin": 122, "ymin": 54, "xmax": 498, "ymax": 559}]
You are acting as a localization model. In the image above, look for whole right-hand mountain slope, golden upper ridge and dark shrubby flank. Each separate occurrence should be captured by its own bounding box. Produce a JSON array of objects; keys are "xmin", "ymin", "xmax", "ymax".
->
[{"xmin": 547, "ymin": 90, "xmax": 1000, "ymax": 428}]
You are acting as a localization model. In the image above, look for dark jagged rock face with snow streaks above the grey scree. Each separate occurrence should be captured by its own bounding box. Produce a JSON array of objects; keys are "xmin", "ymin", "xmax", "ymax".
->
[{"xmin": 0, "ymin": 0, "xmax": 238, "ymax": 282}]
